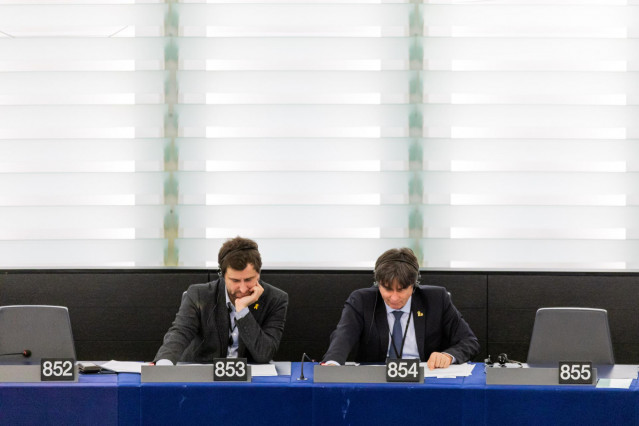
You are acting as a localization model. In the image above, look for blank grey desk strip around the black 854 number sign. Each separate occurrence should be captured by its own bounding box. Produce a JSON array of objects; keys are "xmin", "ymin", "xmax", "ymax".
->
[{"xmin": 313, "ymin": 365, "xmax": 424, "ymax": 383}]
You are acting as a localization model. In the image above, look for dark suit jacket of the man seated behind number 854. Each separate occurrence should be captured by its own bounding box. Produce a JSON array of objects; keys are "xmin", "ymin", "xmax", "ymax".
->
[{"xmin": 323, "ymin": 285, "xmax": 479, "ymax": 364}]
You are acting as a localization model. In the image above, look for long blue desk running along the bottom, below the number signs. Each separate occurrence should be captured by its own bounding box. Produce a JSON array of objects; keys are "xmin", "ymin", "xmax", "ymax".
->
[{"xmin": 0, "ymin": 363, "xmax": 639, "ymax": 426}]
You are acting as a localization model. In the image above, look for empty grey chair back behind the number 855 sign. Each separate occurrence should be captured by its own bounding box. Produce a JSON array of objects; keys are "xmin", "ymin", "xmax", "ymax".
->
[{"xmin": 527, "ymin": 308, "xmax": 615, "ymax": 365}]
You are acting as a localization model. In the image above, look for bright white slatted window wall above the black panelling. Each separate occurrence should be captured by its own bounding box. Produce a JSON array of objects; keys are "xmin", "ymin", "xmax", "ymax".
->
[{"xmin": 0, "ymin": 0, "xmax": 639, "ymax": 270}]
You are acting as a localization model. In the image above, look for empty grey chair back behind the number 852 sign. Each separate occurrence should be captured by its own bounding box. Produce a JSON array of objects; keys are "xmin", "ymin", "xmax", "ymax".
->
[{"xmin": 0, "ymin": 305, "xmax": 76, "ymax": 364}]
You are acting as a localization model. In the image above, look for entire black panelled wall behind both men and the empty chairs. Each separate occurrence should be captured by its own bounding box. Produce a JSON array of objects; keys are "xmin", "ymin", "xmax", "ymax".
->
[{"xmin": 0, "ymin": 269, "xmax": 639, "ymax": 364}]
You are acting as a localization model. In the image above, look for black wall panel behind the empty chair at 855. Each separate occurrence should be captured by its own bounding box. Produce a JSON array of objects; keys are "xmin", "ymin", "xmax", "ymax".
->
[{"xmin": 487, "ymin": 273, "xmax": 639, "ymax": 364}]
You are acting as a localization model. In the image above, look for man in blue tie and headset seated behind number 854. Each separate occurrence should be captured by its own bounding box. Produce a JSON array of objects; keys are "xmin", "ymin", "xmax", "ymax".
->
[{"xmin": 323, "ymin": 248, "xmax": 479, "ymax": 370}]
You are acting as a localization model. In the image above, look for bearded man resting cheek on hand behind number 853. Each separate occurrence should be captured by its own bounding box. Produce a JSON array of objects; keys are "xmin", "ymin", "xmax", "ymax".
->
[{"xmin": 155, "ymin": 237, "xmax": 288, "ymax": 365}]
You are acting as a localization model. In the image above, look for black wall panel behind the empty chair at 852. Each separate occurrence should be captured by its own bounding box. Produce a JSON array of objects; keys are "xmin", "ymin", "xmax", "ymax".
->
[{"xmin": 0, "ymin": 270, "xmax": 208, "ymax": 361}]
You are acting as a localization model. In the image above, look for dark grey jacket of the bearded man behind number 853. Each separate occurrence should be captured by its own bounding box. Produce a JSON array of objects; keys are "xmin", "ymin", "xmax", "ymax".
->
[{"xmin": 155, "ymin": 279, "xmax": 288, "ymax": 364}]
